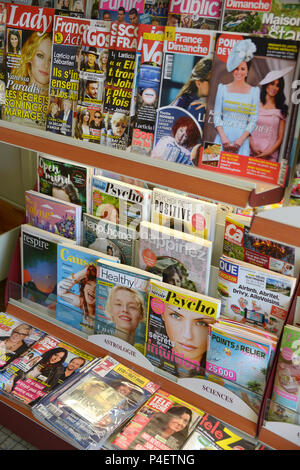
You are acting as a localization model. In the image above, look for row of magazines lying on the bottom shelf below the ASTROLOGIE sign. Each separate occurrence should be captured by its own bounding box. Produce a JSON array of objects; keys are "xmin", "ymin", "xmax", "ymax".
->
[{"xmin": 0, "ymin": 312, "xmax": 269, "ymax": 451}]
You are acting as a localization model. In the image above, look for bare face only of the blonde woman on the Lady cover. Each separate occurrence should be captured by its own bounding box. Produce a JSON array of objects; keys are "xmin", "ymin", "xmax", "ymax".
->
[{"xmin": 31, "ymin": 38, "xmax": 51, "ymax": 87}]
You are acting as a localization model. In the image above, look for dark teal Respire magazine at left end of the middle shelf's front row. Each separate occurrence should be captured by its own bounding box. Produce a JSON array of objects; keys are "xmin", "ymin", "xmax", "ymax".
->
[{"xmin": 20, "ymin": 224, "xmax": 75, "ymax": 313}]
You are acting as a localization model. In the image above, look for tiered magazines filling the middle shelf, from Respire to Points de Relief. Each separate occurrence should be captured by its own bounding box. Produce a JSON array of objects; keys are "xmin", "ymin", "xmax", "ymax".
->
[{"xmin": 17, "ymin": 154, "xmax": 300, "ymax": 430}]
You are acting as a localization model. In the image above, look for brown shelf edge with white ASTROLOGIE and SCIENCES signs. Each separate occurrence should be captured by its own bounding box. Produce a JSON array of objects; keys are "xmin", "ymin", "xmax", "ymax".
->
[{"xmin": 5, "ymin": 283, "xmax": 262, "ymax": 438}]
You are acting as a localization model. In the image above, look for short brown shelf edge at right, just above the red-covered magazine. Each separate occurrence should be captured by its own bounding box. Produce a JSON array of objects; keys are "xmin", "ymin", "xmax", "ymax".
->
[{"xmin": 250, "ymin": 216, "xmax": 300, "ymax": 247}]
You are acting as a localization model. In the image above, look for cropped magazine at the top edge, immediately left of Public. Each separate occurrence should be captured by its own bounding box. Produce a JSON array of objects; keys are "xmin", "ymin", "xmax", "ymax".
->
[{"xmin": 99, "ymin": 0, "xmax": 169, "ymax": 25}]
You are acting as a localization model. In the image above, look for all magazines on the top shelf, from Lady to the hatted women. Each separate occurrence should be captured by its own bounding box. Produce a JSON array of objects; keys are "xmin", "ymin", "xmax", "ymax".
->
[{"xmin": 0, "ymin": 0, "xmax": 300, "ymax": 186}]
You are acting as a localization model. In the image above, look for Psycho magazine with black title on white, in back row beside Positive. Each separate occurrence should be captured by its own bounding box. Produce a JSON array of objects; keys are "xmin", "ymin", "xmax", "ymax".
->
[{"xmin": 92, "ymin": 176, "xmax": 152, "ymax": 230}]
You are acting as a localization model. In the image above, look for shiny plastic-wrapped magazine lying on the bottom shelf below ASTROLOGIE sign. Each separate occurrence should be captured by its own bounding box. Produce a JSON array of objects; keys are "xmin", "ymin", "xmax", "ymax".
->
[{"xmin": 33, "ymin": 356, "xmax": 159, "ymax": 450}]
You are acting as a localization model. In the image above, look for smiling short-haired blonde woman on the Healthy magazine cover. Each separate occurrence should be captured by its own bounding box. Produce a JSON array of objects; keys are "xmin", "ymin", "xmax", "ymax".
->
[{"xmin": 106, "ymin": 286, "xmax": 145, "ymax": 344}]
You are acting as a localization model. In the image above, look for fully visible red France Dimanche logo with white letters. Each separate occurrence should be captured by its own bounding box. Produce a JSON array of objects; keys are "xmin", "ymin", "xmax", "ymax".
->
[{"xmin": 166, "ymin": 31, "xmax": 211, "ymax": 56}]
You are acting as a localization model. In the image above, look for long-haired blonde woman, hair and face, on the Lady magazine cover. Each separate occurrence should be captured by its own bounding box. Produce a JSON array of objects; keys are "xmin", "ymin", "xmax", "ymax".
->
[{"xmin": 8, "ymin": 32, "xmax": 52, "ymax": 96}]
